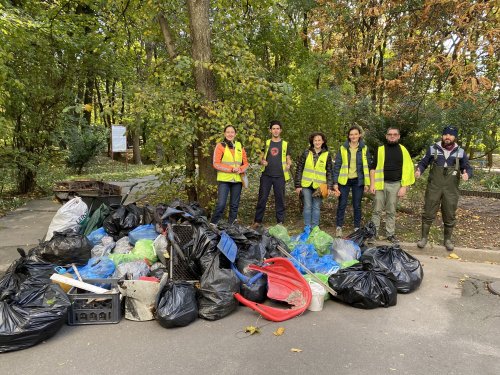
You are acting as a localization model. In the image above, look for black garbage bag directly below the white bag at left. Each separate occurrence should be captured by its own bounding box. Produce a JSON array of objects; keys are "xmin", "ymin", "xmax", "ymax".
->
[{"xmin": 28, "ymin": 229, "xmax": 93, "ymax": 265}]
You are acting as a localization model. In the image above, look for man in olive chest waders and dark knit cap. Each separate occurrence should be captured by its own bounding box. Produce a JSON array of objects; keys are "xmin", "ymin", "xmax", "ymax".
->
[{"xmin": 415, "ymin": 126, "xmax": 472, "ymax": 251}]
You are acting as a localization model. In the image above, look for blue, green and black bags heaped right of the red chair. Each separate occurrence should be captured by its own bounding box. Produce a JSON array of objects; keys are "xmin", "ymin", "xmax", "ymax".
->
[{"xmin": 269, "ymin": 222, "xmax": 423, "ymax": 309}]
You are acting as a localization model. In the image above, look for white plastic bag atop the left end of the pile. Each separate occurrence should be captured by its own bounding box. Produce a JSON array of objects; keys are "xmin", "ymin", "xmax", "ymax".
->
[{"xmin": 45, "ymin": 197, "xmax": 89, "ymax": 241}]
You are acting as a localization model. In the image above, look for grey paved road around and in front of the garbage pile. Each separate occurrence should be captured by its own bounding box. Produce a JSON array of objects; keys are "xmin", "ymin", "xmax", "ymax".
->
[{"xmin": 0, "ymin": 186, "xmax": 500, "ymax": 375}]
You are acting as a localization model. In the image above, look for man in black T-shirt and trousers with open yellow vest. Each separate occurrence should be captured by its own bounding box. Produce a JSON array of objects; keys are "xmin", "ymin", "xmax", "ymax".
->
[{"xmin": 252, "ymin": 120, "xmax": 292, "ymax": 229}]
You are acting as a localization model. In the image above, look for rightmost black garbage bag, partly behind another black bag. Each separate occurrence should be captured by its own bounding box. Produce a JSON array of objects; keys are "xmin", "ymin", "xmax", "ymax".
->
[{"xmin": 360, "ymin": 246, "xmax": 424, "ymax": 293}]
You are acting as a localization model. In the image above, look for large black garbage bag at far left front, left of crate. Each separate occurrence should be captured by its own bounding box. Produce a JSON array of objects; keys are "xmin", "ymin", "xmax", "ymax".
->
[{"xmin": 0, "ymin": 279, "xmax": 70, "ymax": 353}]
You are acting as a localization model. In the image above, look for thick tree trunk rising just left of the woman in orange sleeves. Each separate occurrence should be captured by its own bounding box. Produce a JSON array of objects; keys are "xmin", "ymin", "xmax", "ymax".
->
[{"xmin": 186, "ymin": 0, "xmax": 217, "ymax": 207}]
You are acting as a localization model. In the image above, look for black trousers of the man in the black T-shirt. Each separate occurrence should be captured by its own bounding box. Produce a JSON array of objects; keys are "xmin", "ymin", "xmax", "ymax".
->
[{"xmin": 254, "ymin": 174, "xmax": 285, "ymax": 223}]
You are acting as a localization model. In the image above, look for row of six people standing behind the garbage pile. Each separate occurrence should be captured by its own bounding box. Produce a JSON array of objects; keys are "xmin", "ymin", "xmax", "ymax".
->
[{"xmin": 211, "ymin": 121, "xmax": 472, "ymax": 251}]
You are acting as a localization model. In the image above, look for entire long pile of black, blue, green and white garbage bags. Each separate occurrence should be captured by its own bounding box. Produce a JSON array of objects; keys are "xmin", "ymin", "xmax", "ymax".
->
[{"xmin": 0, "ymin": 197, "xmax": 423, "ymax": 352}]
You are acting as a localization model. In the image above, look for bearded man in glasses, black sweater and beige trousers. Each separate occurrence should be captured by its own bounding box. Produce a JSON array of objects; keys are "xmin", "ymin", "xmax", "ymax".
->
[{"xmin": 370, "ymin": 127, "xmax": 415, "ymax": 244}]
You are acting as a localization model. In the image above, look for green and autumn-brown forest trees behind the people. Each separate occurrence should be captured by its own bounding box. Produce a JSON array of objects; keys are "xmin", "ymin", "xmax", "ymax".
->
[{"xmin": 0, "ymin": 0, "xmax": 500, "ymax": 209}]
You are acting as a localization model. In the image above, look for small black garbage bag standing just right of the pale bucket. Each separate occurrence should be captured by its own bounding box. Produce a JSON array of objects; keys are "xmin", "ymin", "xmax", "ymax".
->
[{"xmin": 155, "ymin": 281, "xmax": 198, "ymax": 328}]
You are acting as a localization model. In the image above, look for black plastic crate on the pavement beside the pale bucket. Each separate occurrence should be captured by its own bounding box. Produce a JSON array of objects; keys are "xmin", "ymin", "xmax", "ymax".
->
[{"xmin": 68, "ymin": 279, "xmax": 122, "ymax": 326}]
